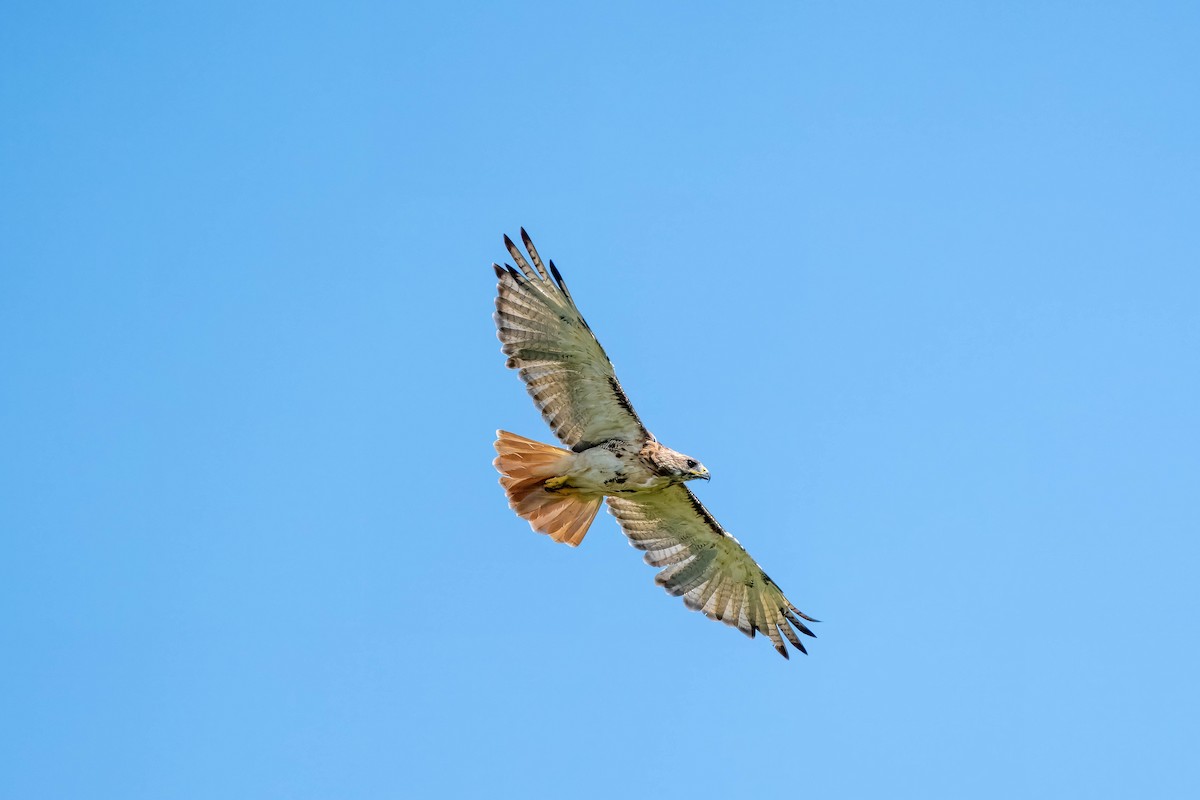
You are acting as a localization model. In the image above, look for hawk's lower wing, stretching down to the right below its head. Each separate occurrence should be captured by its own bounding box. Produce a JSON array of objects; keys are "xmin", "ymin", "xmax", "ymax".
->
[{"xmin": 608, "ymin": 485, "xmax": 816, "ymax": 658}]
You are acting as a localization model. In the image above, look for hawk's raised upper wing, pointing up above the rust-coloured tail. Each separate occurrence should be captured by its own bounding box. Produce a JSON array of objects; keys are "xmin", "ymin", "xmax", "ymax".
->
[{"xmin": 492, "ymin": 228, "xmax": 648, "ymax": 452}]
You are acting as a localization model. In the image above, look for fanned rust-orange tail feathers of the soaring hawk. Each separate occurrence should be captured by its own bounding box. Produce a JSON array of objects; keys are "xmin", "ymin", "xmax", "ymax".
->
[{"xmin": 492, "ymin": 431, "xmax": 604, "ymax": 547}]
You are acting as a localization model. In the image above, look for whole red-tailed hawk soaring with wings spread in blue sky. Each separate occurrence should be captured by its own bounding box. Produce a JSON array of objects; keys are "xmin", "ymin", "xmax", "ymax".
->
[{"xmin": 492, "ymin": 228, "xmax": 816, "ymax": 658}]
